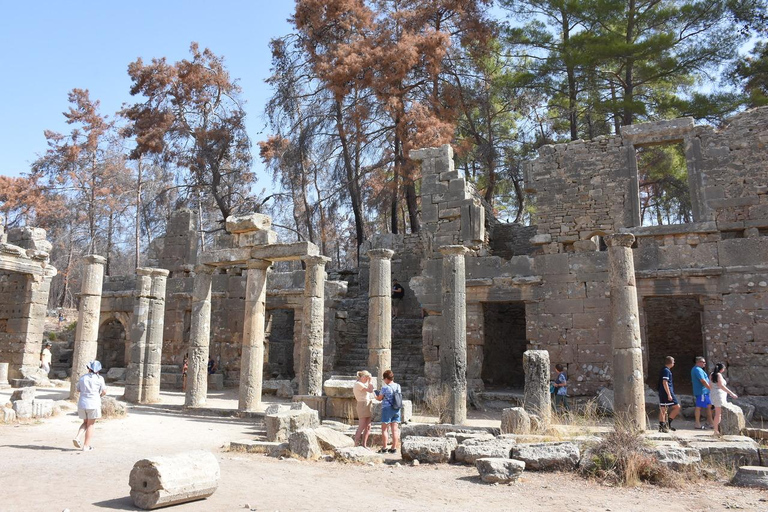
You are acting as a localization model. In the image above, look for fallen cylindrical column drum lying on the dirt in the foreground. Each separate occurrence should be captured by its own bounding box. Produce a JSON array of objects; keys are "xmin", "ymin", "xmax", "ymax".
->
[{"xmin": 128, "ymin": 450, "xmax": 221, "ymax": 510}]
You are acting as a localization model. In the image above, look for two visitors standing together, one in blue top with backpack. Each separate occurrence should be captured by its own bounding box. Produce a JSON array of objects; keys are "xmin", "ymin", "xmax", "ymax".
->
[{"xmin": 353, "ymin": 370, "xmax": 403, "ymax": 453}]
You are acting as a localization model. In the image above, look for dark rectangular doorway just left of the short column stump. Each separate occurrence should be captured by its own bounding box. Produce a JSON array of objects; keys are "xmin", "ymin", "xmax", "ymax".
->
[{"xmin": 481, "ymin": 302, "xmax": 528, "ymax": 389}]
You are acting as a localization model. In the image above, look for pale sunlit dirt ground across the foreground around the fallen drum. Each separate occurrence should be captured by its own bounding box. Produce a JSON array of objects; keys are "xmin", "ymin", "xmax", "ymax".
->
[{"xmin": 0, "ymin": 387, "xmax": 768, "ymax": 512}]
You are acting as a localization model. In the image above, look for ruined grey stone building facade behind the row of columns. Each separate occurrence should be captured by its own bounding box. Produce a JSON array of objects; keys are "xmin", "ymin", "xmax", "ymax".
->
[{"xmin": 82, "ymin": 108, "xmax": 768, "ymax": 395}]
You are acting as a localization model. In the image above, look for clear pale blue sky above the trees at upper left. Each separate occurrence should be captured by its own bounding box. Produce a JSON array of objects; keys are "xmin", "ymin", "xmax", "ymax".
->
[{"xmin": 0, "ymin": 0, "xmax": 294, "ymax": 182}]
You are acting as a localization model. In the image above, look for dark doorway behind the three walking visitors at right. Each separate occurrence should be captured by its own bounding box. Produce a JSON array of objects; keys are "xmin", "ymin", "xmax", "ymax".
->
[{"xmin": 643, "ymin": 296, "xmax": 706, "ymax": 395}]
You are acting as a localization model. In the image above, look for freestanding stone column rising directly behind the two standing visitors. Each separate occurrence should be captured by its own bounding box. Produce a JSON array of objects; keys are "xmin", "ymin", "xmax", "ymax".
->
[{"xmin": 368, "ymin": 249, "xmax": 395, "ymax": 388}]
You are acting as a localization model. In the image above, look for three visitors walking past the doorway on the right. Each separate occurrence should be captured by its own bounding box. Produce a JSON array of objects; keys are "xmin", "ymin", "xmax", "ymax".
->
[{"xmin": 658, "ymin": 356, "xmax": 738, "ymax": 436}]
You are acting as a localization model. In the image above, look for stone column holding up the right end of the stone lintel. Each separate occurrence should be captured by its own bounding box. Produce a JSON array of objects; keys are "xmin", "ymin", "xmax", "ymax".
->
[{"xmin": 299, "ymin": 256, "xmax": 331, "ymax": 396}]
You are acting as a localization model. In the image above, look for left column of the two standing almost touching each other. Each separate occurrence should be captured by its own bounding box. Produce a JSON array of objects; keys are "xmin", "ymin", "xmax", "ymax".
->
[{"xmin": 125, "ymin": 268, "xmax": 152, "ymax": 404}]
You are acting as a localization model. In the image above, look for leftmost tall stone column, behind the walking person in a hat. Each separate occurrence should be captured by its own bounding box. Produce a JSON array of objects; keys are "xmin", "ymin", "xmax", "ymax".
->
[{"xmin": 69, "ymin": 254, "xmax": 107, "ymax": 400}]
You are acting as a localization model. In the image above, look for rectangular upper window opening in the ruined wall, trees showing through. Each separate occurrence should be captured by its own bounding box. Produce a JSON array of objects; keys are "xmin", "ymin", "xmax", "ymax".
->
[{"xmin": 635, "ymin": 142, "xmax": 694, "ymax": 226}]
